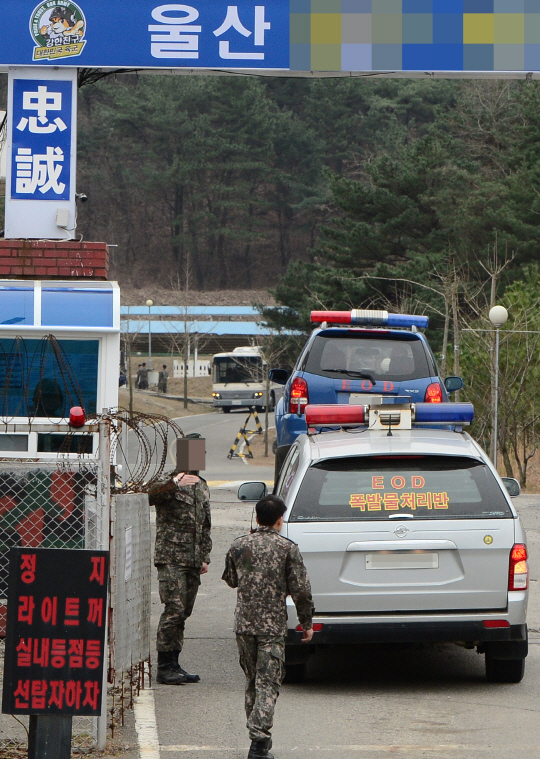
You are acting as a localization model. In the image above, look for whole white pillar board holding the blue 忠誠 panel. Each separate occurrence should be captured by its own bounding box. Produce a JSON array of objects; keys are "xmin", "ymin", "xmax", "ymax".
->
[{"xmin": 5, "ymin": 68, "xmax": 77, "ymax": 240}]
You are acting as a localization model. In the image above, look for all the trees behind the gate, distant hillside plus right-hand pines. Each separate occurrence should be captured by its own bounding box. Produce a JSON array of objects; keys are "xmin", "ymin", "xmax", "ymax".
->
[{"xmin": 49, "ymin": 74, "xmax": 540, "ymax": 483}]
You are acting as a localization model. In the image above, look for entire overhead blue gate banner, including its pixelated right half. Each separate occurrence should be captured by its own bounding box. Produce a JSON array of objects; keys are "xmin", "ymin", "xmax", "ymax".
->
[{"xmin": 0, "ymin": 0, "xmax": 540, "ymax": 72}]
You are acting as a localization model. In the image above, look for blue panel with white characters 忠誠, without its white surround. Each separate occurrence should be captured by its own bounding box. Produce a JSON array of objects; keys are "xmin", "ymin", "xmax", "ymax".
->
[{"xmin": 11, "ymin": 79, "xmax": 73, "ymax": 200}]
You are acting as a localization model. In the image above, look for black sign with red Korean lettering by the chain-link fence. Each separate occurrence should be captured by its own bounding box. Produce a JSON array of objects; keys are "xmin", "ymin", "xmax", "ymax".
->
[{"xmin": 2, "ymin": 548, "xmax": 108, "ymax": 716}]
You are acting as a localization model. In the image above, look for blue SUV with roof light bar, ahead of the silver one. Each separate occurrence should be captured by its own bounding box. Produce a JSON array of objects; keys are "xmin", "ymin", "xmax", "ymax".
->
[{"xmin": 270, "ymin": 309, "xmax": 463, "ymax": 477}]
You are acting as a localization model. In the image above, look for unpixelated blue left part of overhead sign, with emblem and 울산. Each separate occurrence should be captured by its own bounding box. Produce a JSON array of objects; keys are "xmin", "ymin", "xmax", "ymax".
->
[{"xmin": 0, "ymin": 0, "xmax": 289, "ymax": 69}]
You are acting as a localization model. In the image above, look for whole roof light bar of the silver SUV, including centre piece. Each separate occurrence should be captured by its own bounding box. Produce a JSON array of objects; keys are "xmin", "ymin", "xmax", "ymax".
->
[{"xmin": 305, "ymin": 398, "xmax": 474, "ymax": 429}]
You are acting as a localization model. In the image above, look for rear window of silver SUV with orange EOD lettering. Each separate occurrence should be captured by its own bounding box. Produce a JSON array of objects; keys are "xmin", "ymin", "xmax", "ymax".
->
[{"xmin": 289, "ymin": 456, "xmax": 513, "ymax": 522}]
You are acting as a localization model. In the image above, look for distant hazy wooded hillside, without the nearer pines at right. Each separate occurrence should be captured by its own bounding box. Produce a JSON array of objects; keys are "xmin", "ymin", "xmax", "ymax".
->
[{"xmin": 78, "ymin": 74, "xmax": 462, "ymax": 290}]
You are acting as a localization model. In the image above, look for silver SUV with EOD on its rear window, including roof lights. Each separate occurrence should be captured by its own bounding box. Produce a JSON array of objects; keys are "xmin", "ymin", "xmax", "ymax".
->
[{"xmin": 239, "ymin": 399, "xmax": 528, "ymax": 682}]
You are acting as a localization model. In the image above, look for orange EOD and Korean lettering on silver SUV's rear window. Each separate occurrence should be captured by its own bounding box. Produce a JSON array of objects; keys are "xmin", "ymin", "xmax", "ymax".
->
[{"xmin": 349, "ymin": 474, "xmax": 450, "ymax": 511}]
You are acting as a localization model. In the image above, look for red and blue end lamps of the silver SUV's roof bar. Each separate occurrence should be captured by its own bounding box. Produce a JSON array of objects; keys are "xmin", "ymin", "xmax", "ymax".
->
[{"xmin": 305, "ymin": 403, "xmax": 474, "ymax": 427}]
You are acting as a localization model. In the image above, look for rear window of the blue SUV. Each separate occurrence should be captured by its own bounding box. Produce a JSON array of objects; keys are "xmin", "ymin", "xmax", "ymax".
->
[{"xmin": 304, "ymin": 333, "xmax": 431, "ymax": 382}]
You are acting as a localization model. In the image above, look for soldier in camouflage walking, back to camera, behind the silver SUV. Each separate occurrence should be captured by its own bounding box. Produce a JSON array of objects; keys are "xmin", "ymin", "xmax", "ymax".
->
[{"xmin": 222, "ymin": 495, "xmax": 313, "ymax": 759}]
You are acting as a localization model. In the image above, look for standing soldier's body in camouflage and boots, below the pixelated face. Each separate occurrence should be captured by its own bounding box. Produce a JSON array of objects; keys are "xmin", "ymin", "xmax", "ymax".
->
[{"xmin": 149, "ymin": 472, "xmax": 212, "ymax": 685}]
